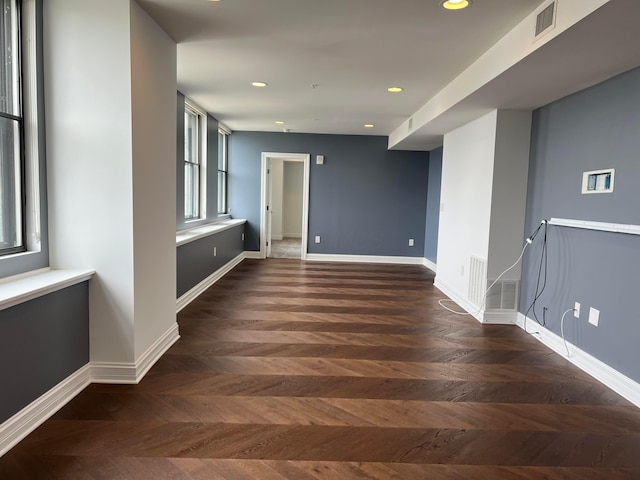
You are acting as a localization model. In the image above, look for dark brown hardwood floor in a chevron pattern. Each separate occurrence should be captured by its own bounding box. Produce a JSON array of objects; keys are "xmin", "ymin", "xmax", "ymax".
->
[{"xmin": 0, "ymin": 259, "xmax": 640, "ymax": 480}]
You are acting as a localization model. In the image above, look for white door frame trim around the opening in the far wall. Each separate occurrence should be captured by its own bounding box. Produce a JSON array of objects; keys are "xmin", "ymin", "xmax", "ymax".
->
[{"xmin": 260, "ymin": 152, "xmax": 311, "ymax": 260}]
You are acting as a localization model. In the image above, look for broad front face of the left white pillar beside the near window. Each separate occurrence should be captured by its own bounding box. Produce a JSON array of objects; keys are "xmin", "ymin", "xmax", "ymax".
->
[{"xmin": 44, "ymin": 0, "xmax": 137, "ymax": 362}]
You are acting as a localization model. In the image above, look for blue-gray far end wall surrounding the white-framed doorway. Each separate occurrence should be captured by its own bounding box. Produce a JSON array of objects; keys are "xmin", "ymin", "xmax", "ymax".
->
[{"xmin": 229, "ymin": 132, "xmax": 429, "ymax": 257}]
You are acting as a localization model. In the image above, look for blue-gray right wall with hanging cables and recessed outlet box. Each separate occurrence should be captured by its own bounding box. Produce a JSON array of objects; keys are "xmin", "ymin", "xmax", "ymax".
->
[{"xmin": 520, "ymin": 69, "xmax": 640, "ymax": 381}]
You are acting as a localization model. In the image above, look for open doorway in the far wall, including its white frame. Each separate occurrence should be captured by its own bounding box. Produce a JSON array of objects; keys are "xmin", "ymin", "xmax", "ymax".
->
[{"xmin": 260, "ymin": 152, "xmax": 310, "ymax": 260}]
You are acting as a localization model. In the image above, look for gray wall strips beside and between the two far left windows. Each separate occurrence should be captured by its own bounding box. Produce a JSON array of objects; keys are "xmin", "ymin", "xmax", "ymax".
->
[{"xmin": 176, "ymin": 92, "xmax": 218, "ymax": 231}]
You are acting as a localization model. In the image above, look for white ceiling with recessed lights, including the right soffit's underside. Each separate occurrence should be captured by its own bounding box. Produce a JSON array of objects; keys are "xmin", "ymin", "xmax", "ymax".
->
[{"xmin": 138, "ymin": 0, "xmax": 640, "ymax": 149}]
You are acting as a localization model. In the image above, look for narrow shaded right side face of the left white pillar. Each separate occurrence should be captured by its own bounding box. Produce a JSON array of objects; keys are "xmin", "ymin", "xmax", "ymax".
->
[{"xmin": 131, "ymin": 2, "xmax": 177, "ymax": 359}]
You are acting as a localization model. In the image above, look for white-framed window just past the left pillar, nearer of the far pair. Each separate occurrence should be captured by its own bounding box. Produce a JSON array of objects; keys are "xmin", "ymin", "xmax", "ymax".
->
[{"xmin": 183, "ymin": 102, "xmax": 207, "ymax": 223}]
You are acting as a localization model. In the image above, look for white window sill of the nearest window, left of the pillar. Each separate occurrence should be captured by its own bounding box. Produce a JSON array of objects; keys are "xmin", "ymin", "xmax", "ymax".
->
[{"xmin": 0, "ymin": 268, "xmax": 95, "ymax": 310}]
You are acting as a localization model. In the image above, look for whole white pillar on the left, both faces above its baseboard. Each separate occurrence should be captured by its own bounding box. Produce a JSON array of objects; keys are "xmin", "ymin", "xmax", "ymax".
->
[{"xmin": 44, "ymin": 0, "xmax": 176, "ymax": 364}]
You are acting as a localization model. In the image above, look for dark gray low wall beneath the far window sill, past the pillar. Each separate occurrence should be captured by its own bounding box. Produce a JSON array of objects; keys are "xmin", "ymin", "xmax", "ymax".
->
[{"xmin": 177, "ymin": 225, "xmax": 244, "ymax": 298}]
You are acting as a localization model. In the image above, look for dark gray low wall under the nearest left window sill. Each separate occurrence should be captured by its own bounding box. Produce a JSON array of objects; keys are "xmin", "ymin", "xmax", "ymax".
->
[{"xmin": 0, "ymin": 282, "xmax": 89, "ymax": 423}]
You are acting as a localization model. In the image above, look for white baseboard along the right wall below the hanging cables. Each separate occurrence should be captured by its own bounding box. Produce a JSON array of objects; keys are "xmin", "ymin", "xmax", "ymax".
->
[{"xmin": 517, "ymin": 313, "xmax": 640, "ymax": 407}]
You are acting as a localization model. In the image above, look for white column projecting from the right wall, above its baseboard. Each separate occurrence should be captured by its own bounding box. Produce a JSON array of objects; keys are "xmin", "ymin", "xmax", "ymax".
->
[{"xmin": 436, "ymin": 110, "xmax": 531, "ymax": 323}]
